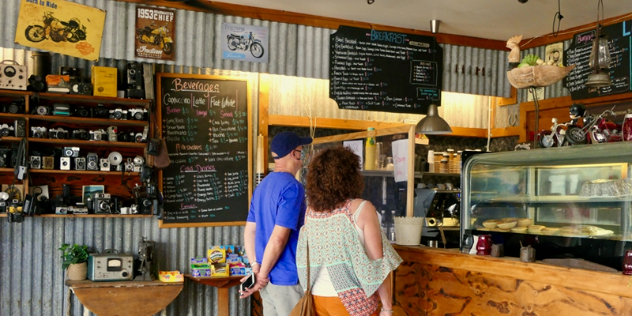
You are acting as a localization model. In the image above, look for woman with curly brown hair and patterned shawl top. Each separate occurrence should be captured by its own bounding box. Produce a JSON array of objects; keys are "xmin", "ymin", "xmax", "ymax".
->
[{"xmin": 296, "ymin": 147, "xmax": 402, "ymax": 316}]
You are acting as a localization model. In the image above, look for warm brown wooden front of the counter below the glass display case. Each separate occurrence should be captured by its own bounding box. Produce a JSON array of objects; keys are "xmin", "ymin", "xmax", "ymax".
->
[{"xmin": 394, "ymin": 246, "xmax": 632, "ymax": 316}]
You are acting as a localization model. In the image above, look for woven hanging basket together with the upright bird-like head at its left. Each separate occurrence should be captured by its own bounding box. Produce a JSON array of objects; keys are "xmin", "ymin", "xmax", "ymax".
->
[{"xmin": 507, "ymin": 35, "xmax": 575, "ymax": 89}]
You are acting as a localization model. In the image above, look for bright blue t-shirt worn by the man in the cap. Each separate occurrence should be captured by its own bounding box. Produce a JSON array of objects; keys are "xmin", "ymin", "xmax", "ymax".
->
[{"xmin": 248, "ymin": 172, "xmax": 306, "ymax": 285}]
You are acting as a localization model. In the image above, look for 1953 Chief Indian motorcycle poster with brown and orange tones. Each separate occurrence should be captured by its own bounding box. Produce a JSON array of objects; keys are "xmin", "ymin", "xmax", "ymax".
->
[{"xmin": 136, "ymin": 7, "xmax": 176, "ymax": 60}]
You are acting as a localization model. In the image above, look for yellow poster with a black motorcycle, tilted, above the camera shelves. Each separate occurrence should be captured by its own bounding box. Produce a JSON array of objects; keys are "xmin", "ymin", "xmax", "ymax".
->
[{"xmin": 15, "ymin": 0, "xmax": 105, "ymax": 61}]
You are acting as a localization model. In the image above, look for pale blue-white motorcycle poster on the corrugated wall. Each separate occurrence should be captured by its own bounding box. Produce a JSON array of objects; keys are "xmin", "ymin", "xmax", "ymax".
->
[{"xmin": 221, "ymin": 23, "xmax": 268, "ymax": 63}]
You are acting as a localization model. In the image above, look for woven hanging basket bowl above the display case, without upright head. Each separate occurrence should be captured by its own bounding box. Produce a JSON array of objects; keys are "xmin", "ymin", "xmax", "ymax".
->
[{"xmin": 507, "ymin": 65, "xmax": 575, "ymax": 89}]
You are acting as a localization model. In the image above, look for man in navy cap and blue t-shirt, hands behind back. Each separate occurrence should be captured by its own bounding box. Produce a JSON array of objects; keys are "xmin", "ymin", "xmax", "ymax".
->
[{"xmin": 241, "ymin": 132, "xmax": 312, "ymax": 316}]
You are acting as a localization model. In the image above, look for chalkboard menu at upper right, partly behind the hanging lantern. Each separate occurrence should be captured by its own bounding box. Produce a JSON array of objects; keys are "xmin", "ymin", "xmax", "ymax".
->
[{"xmin": 564, "ymin": 20, "xmax": 632, "ymax": 100}]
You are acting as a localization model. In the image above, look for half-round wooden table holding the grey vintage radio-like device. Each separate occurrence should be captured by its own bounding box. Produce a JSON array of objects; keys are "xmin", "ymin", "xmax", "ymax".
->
[{"xmin": 65, "ymin": 280, "xmax": 184, "ymax": 316}]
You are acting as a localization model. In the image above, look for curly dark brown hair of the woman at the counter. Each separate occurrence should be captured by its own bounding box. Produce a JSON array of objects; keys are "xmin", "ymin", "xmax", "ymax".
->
[{"xmin": 305, "ymin": 146, "xmax": 364, "ymax": 212}]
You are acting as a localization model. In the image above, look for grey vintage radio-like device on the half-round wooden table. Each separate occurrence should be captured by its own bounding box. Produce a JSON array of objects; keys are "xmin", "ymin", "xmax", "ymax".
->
[{"xmin": 88, "ymin": 249, "xmax": 134, "ymax": 281}]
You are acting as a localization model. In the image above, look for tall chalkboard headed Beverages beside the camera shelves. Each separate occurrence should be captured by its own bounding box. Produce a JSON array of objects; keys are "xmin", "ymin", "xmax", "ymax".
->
[{"xmin": 156, "ymin": 74, "xmax": 252, "ymax": 227}]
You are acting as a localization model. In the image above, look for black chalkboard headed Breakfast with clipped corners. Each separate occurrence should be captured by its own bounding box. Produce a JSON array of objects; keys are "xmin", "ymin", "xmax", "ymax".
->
[{"xmin": 329, "ymin": 26, "xmax": 443, "ymax": 114}]
